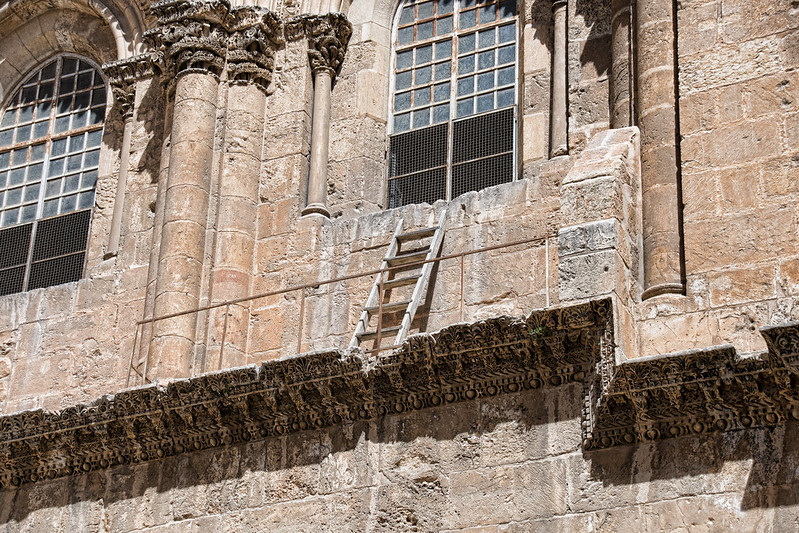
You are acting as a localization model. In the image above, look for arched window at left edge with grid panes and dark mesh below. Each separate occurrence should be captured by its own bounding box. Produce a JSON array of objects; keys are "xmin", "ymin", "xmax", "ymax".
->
[{"xmin": 0, "ymin": 56, "xmax": 106, "ymax": 295}]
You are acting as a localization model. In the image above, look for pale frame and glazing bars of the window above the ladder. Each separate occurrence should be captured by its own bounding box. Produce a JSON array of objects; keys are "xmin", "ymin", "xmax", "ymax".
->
[{"xmin": 383, "ymin": 0, "xmax": 522, "ymax": 209}]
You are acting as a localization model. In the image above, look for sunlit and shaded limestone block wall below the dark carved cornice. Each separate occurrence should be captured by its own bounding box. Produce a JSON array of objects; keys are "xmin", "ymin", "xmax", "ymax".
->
[{"xmin": 0, "ymin": 384, "xmax": 799, "ymax": 533}]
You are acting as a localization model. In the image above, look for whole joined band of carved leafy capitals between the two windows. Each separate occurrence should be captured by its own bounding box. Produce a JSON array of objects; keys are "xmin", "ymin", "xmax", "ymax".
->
[{"xmin": 103, "ymin": 0, "xmax": 352, "ymax": 105}]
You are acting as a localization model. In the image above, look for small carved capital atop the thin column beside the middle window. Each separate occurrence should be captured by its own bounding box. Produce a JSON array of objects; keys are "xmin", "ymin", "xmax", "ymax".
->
[{"xmin": 286, "ymin": 13, "xmax": 352, "ymax": 77}]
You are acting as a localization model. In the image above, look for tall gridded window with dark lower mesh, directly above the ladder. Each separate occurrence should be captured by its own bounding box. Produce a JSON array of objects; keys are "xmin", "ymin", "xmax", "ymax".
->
[{"xmin": 387, "ymin": 0, "xmax": 518, "ymax": 208}]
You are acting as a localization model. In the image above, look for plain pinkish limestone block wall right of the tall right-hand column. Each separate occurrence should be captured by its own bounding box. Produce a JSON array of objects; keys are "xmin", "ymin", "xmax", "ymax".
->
[{"xmin": 638, "ymin": 0, "xmax": 799, "ymax": 354}]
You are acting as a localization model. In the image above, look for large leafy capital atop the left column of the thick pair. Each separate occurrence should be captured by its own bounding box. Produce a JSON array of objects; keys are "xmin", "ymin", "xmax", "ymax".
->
[{"xmin": 145, "ymin": 0, "xmax": 230, "ymax": 77}]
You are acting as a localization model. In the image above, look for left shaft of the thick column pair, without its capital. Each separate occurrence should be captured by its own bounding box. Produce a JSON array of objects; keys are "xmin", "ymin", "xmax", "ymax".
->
[{"xmin": 151, "ymin": 71, "xmax": 219, "ymax": 379}]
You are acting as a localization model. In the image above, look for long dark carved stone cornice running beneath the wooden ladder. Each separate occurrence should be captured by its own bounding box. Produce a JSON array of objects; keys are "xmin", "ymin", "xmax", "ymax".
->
[{"xmin": 0, "ymin": 300, "xmax": 799, "ymax": 488}]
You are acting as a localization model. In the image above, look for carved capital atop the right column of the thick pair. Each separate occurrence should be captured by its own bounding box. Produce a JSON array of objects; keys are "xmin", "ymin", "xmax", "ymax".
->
[{"xmin": 227, "ymin": 7, "xmax": 283, "ymax": 90}]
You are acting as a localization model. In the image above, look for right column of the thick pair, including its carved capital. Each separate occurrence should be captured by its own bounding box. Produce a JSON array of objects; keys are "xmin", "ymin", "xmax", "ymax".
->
[{"xmin": 205, "ymin": 8, "xmax": 282, "ymax": 370}]
